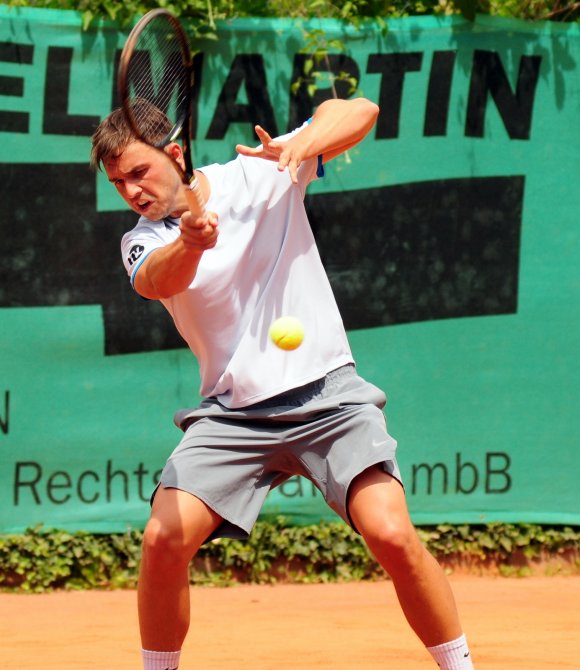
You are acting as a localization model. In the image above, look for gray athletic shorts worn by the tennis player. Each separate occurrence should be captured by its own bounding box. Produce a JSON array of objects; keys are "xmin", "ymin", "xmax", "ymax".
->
[{"xmin": 160, "ymin": 365, "xmax": 401, "ymax": 539}]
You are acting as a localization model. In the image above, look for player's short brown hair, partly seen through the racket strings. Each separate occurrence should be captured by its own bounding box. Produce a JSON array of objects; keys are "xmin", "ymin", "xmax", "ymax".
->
[{"xmin": 90, "ymin": 99, "xmax": 172, "ymax": 170}]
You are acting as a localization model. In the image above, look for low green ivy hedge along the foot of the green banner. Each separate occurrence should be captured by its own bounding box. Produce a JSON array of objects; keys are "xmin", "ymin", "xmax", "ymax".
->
[{"xmin": 0, "ymin": 518, "xmax": 580, "ymax": 592}]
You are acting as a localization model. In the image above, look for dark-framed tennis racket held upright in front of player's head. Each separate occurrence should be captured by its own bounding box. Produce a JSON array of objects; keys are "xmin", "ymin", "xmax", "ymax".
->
[{"xmin": 117, "ymin": 9, "xmax": 205, "ymax": 216}]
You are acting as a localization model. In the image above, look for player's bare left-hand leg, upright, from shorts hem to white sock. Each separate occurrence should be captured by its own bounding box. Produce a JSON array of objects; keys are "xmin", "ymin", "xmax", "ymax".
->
[{"xmin": 138, "ymin": 487, "xmax": 222, "ymax": 656}]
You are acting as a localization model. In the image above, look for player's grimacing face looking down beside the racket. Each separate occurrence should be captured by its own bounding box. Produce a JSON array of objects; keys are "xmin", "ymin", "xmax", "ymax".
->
[{"xmin": 103, "ymin": 141, "xmax": 186, "ymax": 221}]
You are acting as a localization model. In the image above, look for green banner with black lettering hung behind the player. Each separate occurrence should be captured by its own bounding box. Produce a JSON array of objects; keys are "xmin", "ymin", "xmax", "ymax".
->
[{"xmin": 0, "ymin": 6, "xmax": 580, "ymax": 532}]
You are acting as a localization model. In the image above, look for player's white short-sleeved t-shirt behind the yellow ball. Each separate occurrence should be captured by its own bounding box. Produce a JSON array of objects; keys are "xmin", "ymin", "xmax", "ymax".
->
[{"xmin": 121, "ymin": 137, "xmax": 353, "ymax": 408}]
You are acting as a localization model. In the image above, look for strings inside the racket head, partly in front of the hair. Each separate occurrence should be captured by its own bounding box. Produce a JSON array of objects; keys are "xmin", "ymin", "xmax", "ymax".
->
[{"xmin": 127, "ymin": 19, "xmax": 190, "ymax": 146}]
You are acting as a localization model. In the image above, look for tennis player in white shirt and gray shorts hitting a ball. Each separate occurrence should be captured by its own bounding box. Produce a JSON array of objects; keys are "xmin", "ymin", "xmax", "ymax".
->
[{"xmin": 91, "ymin": 98, "xmax": 473, "ymax": 670}]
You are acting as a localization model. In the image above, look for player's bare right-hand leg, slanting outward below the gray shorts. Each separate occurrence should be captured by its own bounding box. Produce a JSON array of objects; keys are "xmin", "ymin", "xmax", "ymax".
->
[{"xmin": 349, "ymin": 466, "xmax": 471, "ymax": 667}]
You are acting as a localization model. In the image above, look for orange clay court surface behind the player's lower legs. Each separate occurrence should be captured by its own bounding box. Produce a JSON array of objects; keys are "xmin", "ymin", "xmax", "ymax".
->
[{"xmin": 0, "ymin": 575, "xmax": 580, "ymax": 670}]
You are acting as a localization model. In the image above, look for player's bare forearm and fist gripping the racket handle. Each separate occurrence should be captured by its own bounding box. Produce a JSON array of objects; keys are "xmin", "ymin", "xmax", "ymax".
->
[{"xmin": 133, "ymin": 212, "xmax": 218, "ymax": 300}]
